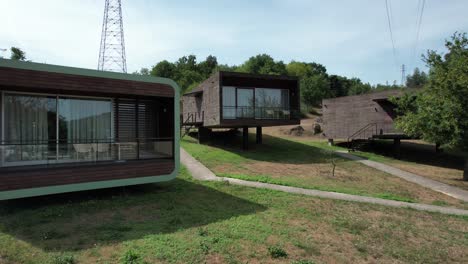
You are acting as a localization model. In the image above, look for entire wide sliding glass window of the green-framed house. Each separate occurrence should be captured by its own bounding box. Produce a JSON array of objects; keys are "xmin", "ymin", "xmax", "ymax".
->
[{"xmin": 1, "ymin": 93, "xmax": 112, "ymax": 166}]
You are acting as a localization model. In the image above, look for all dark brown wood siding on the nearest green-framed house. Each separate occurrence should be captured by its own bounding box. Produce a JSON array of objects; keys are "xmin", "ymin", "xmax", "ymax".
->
[{"xmin": 0, "ymin": 64, "xmax": 176, "ymax": 191}]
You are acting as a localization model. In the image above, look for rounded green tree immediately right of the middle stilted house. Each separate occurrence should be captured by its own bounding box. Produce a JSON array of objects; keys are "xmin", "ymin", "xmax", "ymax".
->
[{"xmin": 300, "ymin": 75, "xmax": 331, "ymax": 106}]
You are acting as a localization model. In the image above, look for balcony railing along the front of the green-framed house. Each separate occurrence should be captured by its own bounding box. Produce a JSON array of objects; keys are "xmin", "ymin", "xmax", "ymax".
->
[{"xmin": 0, "ymin": 138, "xmax": 174, "ymax": 167}]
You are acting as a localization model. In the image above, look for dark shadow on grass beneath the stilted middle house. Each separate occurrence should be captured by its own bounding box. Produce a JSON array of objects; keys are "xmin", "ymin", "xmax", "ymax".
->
[{"xmin": 186, "ymin": 132, "xmax": 336, "ymax": 164}]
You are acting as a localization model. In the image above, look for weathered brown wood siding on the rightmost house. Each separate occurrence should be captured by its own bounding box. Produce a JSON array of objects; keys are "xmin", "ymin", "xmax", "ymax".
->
[{"xmin": 322, "ymin": 90, "xmax": 404, "ymax": 139}]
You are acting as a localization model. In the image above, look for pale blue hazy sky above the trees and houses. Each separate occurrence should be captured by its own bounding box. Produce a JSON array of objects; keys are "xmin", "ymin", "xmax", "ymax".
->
[{"xmin": 0, "ymin": 0, "xmax": 468, "ymax": 84}]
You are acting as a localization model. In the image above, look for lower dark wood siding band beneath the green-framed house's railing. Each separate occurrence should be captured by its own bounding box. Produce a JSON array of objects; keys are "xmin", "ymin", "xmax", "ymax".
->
[{"xmin": 0, "ymin": 160, "xmax": 175, "ymax": 191}]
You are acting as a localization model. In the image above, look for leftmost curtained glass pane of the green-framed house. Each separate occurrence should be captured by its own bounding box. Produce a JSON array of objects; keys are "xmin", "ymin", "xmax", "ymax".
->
[{"xmin": 2, "ymin": 94, "xmax": 57, "ymax": 164}]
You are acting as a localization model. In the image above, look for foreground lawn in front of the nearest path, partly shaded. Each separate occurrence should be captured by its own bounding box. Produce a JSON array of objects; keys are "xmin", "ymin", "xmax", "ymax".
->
[{"xmin": 0, "ymin": 169, "xmax": 468, "ymax": 263}]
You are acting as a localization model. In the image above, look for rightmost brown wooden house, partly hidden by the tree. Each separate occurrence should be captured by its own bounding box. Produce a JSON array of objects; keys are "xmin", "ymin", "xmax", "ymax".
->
[{"xmin": 322, "ymin": 89, "xmax": 412, "ymax": 155}]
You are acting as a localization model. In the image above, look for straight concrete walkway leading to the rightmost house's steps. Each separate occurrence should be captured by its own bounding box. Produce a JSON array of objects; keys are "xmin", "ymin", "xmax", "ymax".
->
[{"xmin": 336, "ymin": 151, "xmax": 468, "ymax": 202}]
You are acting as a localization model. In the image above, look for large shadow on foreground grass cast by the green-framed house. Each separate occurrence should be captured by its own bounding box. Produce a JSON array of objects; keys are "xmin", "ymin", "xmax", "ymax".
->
[{"xmin": 0, "ymin": 179, "xmax": 266, "ymax": 252}]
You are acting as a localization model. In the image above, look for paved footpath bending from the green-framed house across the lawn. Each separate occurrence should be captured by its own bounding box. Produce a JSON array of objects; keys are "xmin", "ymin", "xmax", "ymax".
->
[{"xmin": 180, "ymin": 148, "xmax": 468, "ymax": 215}]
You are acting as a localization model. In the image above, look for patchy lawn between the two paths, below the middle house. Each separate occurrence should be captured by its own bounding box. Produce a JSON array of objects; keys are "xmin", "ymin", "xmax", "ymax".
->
[{"xmin": 182, "ymin": 135, "xmax": 468, "ymax": 208}]
